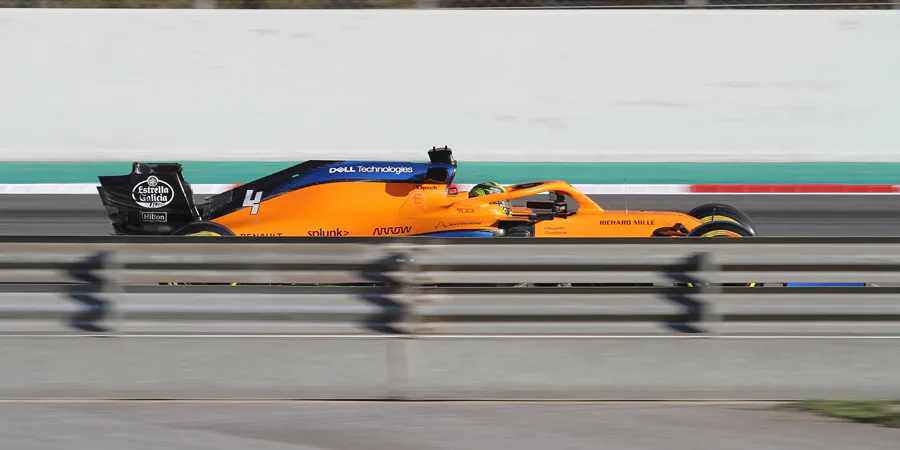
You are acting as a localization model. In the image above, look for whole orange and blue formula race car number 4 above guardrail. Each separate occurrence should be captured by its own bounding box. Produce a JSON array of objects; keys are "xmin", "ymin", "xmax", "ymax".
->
[{"xmin": 98, "ymin": 147, "xmax": 756, "ymax": 238}]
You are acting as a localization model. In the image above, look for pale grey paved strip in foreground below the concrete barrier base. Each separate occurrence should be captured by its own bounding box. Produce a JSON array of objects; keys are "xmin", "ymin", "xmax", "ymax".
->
[{"xmin": 0, "ymin": 402, "xmax": 900, "ymax": 450}]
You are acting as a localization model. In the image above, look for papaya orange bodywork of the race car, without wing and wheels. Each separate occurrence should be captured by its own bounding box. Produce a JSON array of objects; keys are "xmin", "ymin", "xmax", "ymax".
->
[{"xmin": 212, "ymin": 181, "xmax": 703, "ymax": 238}]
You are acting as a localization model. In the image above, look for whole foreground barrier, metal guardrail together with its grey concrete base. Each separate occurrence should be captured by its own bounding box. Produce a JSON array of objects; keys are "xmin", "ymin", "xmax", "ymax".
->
[{"xmin": 0, "ymin": 237, "xmax": 900, "ymax": 399}]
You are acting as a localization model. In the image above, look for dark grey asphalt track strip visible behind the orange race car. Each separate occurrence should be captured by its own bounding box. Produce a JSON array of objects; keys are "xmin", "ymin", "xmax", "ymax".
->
[{"xmin": 0, "ymin": 195, "xmax": 900, "ymax": 237}]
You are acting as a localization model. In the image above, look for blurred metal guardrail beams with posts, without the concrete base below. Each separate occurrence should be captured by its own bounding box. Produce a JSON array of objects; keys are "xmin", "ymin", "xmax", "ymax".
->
[{"xmin": 0, "ymin": 237, "xmax": 900, "ymax": 337}]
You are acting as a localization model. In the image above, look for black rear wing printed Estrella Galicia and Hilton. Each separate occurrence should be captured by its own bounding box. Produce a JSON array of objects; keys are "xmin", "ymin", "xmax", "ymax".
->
[{"xmin": 97, "ymin": 162, "xmax": 200, "ymax": 235}]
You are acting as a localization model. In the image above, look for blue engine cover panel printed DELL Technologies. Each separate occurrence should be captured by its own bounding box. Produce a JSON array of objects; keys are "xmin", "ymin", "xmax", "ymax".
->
[{"xmin": 273, "ymin": 161, "xmax": 456, "ymax": 195}]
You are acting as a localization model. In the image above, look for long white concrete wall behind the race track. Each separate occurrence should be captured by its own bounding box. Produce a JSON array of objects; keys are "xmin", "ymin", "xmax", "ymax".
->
[{"xmin": 0, "ymin": 10, "xmax": 900, "ymax": 161}]
